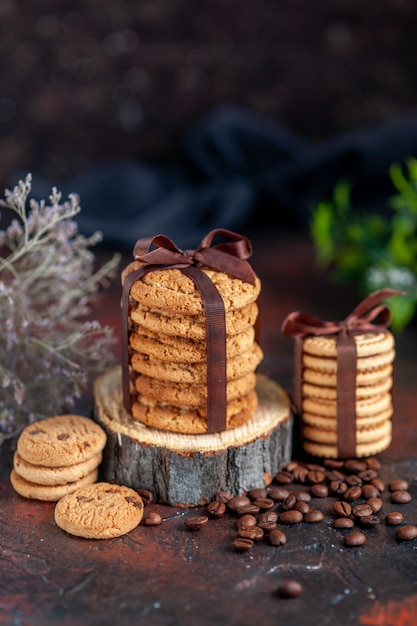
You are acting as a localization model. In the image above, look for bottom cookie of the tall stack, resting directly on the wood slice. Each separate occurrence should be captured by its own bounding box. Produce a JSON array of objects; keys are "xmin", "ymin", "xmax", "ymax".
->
[{"xmin": 131, "ymin": 391, "xmax": 258, "ymax": 435}]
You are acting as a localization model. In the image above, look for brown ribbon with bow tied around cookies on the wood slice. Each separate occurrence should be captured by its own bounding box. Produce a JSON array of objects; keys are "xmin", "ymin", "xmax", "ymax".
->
[{"xmin": 122, "ymin": 228, "xmax": 256, "ymax": 432}]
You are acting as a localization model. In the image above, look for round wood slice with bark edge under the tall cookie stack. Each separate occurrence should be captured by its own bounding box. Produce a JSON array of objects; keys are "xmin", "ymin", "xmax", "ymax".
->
[{"xmin": 94, "ymin": 367, "xmax": 294, "ymax": 507}]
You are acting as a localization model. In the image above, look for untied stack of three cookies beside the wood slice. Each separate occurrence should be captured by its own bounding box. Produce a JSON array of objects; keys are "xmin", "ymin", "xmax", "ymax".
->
[{"xmin": 10, "ymin": 415, "xmax": 106, "ymax": 502}]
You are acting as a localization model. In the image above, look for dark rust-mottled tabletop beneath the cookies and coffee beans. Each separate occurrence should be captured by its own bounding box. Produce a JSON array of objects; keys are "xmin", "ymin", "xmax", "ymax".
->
[{"xmin": 0, "ymin": 233, "xmax": 417, "ymax": 626}]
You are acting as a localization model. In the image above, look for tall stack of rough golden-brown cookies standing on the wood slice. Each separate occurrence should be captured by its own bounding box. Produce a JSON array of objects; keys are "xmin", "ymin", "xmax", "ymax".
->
[{"xmin": 122, "ymin": 262, "xmax": 263, "ymax": 434}]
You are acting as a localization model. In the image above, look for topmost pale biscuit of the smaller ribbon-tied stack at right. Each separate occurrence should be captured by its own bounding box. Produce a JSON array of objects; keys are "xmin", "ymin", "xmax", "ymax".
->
[{"xmin": 303, "ymin": 331, "xmax": 394, "ymax": 358}]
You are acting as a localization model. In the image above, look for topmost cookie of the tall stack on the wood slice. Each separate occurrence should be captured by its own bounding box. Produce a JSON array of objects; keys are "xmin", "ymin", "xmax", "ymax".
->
[{"xmin": 122, "ymin": 261, "xmax": 261, "ymax": 315}]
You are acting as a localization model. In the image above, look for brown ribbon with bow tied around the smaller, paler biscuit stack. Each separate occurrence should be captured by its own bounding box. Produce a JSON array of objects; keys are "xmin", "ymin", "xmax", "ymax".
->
[{"xmin": 282, "ymin": 288, "xmax": 405, "ymax": 458}]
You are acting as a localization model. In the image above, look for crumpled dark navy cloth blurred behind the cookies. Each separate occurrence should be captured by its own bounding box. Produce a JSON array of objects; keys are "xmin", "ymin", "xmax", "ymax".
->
[{"xmin": 24, "ymin": 106, "xmax": 417, "ymax": 248}]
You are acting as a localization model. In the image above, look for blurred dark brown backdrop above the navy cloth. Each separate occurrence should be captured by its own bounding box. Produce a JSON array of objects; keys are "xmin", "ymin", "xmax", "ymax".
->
[{"xmin": 0, "ymin": 0, "xmax": 417, "ymax": 244}]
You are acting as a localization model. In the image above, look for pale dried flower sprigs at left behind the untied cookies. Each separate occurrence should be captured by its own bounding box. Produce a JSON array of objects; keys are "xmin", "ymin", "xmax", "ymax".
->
[{"xmin": 0, "ymin": 174, "xmax": 120, "ymax": 444}]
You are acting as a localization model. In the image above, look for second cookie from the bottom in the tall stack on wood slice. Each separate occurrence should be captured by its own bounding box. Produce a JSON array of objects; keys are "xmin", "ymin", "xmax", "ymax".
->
[{"xmin": 135, "ymin": 372, "xmax": 256, "ymax": 407}]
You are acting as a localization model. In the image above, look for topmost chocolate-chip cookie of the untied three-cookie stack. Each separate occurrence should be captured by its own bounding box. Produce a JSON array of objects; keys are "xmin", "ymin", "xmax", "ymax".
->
[{"xmin": 17, "ymin": 415, "xmax": 107, "ymax": 467}]
